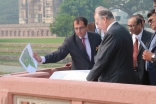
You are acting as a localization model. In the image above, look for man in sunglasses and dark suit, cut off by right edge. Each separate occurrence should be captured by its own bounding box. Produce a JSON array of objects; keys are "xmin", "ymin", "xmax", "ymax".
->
[{"xmin": 143, "ymin": 9, "xmax": 156, "ymax": 85}]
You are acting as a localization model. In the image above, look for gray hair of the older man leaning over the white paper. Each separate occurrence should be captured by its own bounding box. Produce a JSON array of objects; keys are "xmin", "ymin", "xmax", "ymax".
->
[{"xmin": 98, "ymin": 9, "xmax": 114, "ymax": 19}]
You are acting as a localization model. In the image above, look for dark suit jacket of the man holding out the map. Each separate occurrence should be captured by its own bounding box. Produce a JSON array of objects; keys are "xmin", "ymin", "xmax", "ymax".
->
[{"xmin": 45, "ymin": 32, "xmax": 101, "ymax": 70}]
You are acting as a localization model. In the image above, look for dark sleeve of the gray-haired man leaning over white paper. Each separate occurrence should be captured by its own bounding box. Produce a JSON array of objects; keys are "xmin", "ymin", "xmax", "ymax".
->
[{"xmin": 87, "ymin": 34, "xmax": 118, "ymax": 81}]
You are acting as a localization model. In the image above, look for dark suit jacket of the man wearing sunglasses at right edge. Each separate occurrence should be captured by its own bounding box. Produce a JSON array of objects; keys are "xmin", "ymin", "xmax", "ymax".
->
[{"xmin": 148, "ymin": 33, "xmax": 156, "ymax": 85}]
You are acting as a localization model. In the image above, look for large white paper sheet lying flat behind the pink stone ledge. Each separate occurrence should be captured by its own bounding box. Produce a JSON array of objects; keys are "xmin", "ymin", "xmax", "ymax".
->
[{"xmin": 50, "ymin": 70, "xmax": 90, "ymax": 81}]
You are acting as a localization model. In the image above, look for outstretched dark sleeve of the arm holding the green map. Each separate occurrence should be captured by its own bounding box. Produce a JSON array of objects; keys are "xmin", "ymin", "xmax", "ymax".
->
[{"xmin": 45, "ymin": 38, "xmax": 69, "ymax": 63}]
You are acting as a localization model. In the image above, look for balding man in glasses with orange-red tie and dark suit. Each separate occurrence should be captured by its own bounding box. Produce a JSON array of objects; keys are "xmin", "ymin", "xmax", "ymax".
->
[{"xmin": 128, "ymin": 15, "xmax": 152, "ymax": 85}]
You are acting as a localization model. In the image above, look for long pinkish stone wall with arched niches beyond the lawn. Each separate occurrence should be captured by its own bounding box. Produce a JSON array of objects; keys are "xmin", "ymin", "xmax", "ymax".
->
[{"xmin": 0, "ymin": 23, "xmax": 56, "ymax": 37}]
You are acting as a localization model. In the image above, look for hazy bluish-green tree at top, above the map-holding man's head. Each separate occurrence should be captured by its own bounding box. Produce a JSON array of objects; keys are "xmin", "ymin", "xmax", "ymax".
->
[{"xmin": 60, "ymin": 0, "xmax": 107, "ymax": 22}]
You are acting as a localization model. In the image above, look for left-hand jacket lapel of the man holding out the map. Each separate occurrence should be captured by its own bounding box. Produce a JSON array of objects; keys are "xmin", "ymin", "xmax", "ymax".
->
[{"xmin": 75, "ymin": 34, "xmax": 90, "ymax": 62}]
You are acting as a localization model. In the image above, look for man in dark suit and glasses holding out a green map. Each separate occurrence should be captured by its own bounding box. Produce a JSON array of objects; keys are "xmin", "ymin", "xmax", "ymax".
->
[{"xmin": 33, "ymin": 17, "xmax": 101, "ymax": 70}]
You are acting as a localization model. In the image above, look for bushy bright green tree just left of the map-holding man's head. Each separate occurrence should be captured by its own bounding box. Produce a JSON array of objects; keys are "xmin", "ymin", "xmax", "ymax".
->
[{"xmin": 50, "ymin": 13, "xmax": 75, "ymax": 37}]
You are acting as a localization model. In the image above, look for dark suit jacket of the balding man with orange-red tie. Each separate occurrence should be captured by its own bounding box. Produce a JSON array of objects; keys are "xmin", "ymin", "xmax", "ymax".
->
[{"xmin": 137, "ymin": 30, "xmax": 152, "ymax": 84}]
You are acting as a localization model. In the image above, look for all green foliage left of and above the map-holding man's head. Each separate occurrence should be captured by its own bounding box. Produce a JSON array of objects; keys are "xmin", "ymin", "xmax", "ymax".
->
[{"xmin": 50, "ymin": 0, "xmax": 106, "ymax": 37}]
